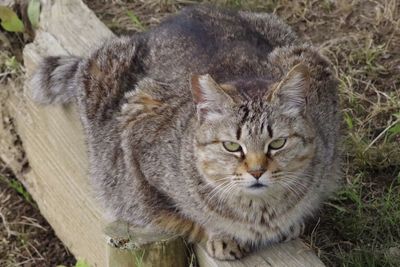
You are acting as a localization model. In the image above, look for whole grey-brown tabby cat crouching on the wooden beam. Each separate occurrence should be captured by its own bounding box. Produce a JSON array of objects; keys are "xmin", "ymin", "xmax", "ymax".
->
[{"xmin": 31, "ymin": 6, "xmax": 340, "ymax": 260}]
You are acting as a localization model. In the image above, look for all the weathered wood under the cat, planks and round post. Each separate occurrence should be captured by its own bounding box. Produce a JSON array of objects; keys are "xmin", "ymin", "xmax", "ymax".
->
[{"xmin": 0, "ymin": 0, "xmax": 323, "ymax": 266}]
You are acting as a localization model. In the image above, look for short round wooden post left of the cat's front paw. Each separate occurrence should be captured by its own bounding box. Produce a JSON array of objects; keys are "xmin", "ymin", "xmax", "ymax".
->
[{"xmin": 105, "ymin": 222, "xmax": 188, "ymax": 267}]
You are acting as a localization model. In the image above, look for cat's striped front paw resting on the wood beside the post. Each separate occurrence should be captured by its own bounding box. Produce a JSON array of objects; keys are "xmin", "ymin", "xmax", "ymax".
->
[{"xmin": 206, "ymin": 238, "xmax": 250, "ymax": 260}]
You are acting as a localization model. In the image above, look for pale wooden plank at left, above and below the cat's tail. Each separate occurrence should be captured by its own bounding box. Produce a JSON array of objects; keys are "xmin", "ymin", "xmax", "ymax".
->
[{"xmin": 10, "ymin": 0, "xmax": 112, "ymax": 266}]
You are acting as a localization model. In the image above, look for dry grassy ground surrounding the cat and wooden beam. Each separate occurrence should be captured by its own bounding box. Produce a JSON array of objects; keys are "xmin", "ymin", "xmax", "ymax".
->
[{"xmin": 0, "ymin": 0, "xmax": 400, "ymax": 267}]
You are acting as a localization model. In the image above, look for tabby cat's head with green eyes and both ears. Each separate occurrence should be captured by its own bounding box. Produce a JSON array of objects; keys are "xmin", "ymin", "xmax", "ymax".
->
[{"xmin": 191, "ymin": 64, "xmax": 315, "ymax": 199}]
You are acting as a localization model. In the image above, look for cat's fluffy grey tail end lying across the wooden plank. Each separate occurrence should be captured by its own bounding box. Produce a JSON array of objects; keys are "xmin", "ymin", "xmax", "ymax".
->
[{"xmin": 31, "ymin": 56, "xmax": 83, "ymax": 104}]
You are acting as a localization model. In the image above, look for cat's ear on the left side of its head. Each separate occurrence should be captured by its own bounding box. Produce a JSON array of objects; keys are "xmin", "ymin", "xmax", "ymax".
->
[{"xmin": 191, "ymin": 74, "xmax": 233, "ymax": 122}]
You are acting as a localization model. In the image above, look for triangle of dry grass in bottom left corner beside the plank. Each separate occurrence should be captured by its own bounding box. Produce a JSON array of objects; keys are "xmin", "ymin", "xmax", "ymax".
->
[{"xmin": 0, "ymin": 162, "xmax": 75, "ymax": 267}]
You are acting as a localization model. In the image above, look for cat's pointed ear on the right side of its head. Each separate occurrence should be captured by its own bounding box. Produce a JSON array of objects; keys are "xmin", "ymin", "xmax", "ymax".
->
[{"xmin": 266, "ymin": 63, "xmax": 310, "ymax": 116}]
